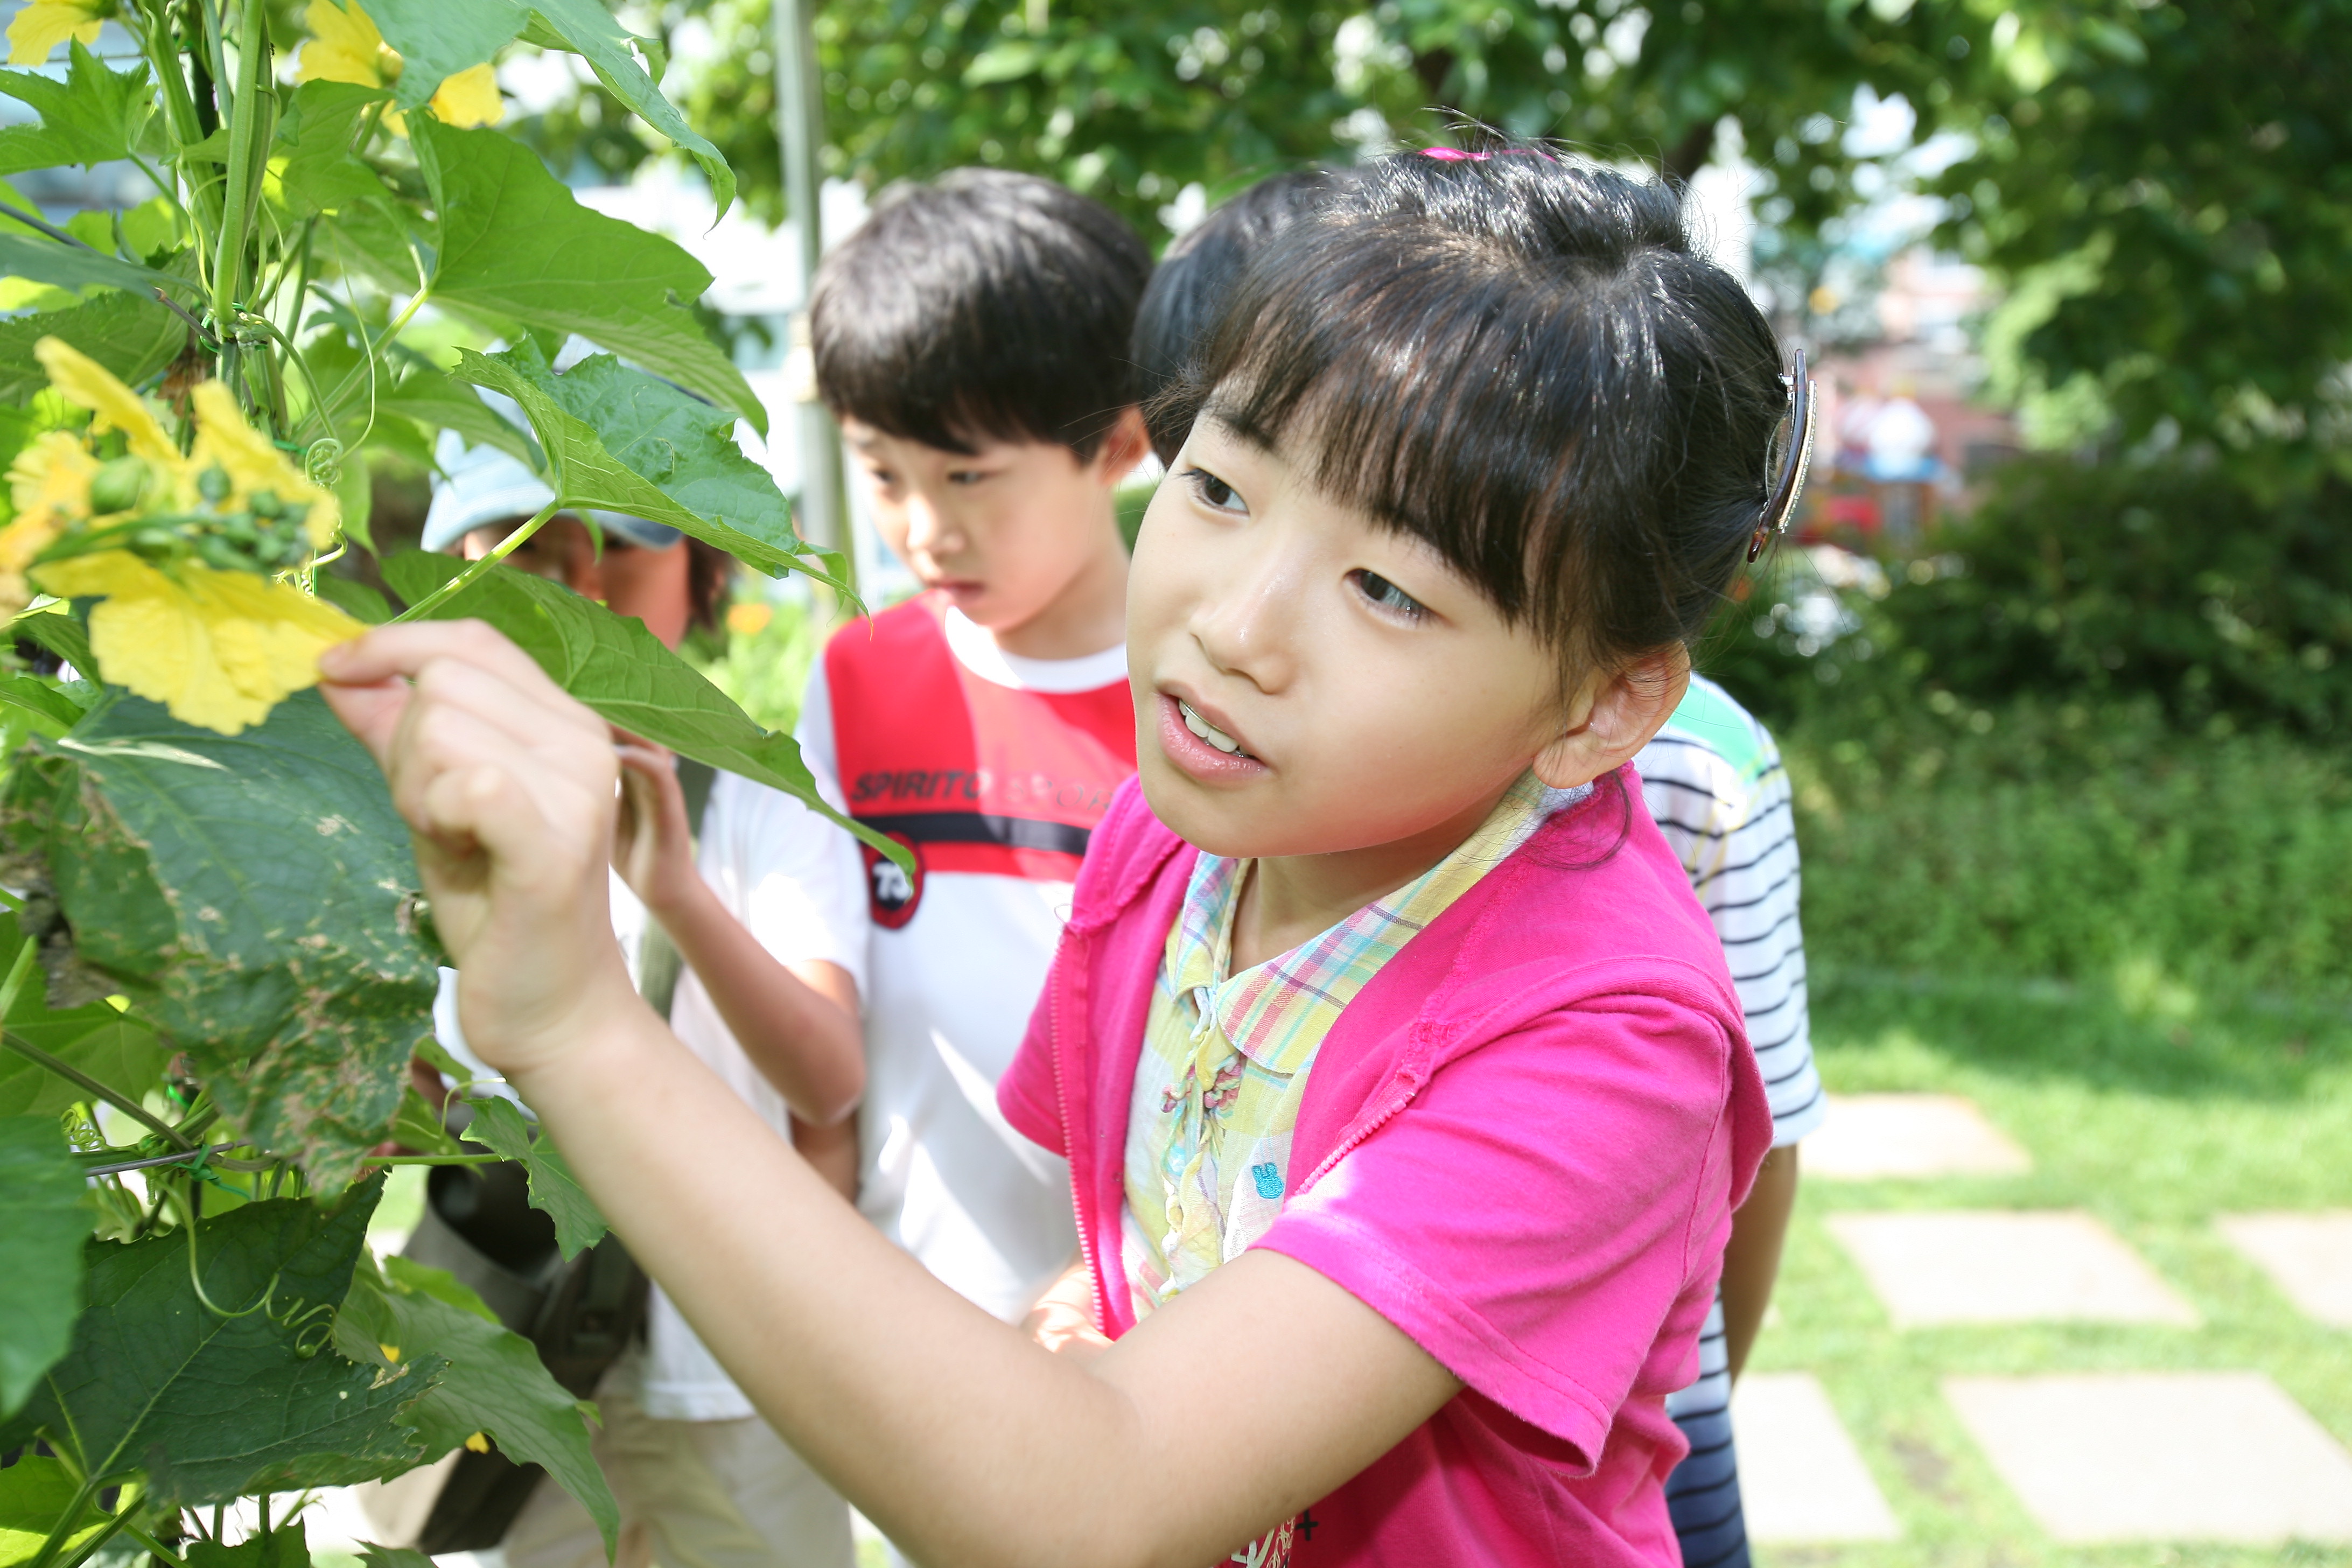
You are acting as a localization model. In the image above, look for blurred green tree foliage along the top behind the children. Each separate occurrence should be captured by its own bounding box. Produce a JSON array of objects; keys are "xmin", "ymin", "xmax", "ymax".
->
[{"xmin": 529, "ymin": 0, "xmax": 2352, "ymax": 454}]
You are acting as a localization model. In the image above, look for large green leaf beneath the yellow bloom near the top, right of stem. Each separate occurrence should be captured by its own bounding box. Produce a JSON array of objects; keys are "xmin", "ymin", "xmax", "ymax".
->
[{"xmin": 411, "ymin": 117, "xmax": 767, "ymax": 432}]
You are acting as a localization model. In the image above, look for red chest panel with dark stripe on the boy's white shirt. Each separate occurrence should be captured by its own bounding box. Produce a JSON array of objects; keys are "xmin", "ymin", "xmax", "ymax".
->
[{"xmin": 825, "ymin": 595, "xmax": 1136, "ymax": 928}]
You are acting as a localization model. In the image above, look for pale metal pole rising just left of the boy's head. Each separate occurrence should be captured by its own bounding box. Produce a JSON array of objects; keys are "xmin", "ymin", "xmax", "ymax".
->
[{"xmin": 769, "ymin": 0, "xmax": 858, "ymax": 601}]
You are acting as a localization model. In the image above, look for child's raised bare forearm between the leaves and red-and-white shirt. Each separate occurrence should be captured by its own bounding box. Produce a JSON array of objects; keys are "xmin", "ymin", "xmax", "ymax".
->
[{"xmin": 614, "ymin": 745, "xmax": 865, "ymax": 1129}]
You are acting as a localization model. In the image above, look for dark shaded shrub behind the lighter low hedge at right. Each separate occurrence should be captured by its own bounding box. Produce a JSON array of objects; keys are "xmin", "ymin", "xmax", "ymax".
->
[{"xmin": 1703, "ymin": 456, "xmax": 2352, "ymax": 736}]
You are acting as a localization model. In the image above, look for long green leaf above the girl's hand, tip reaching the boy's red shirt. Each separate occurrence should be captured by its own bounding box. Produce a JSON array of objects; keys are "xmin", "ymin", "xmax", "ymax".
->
[{"xmin": 383, "ymin": 550, "xmax": 915, "ymax": 877}]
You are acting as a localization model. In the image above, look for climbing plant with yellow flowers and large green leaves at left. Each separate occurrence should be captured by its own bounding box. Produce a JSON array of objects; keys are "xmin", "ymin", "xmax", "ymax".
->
[{"xmin": 0, "ymin": 0, "xmax": 884, "ymax": 1568}]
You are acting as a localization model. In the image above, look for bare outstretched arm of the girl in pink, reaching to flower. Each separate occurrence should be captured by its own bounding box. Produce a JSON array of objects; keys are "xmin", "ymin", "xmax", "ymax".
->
[{"xmin": 322, "ymin": 623, "xmax": 1461, "ymax": 1568}]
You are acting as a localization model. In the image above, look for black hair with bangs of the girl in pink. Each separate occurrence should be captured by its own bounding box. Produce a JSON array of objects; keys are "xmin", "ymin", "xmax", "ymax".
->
[{"xmin": 1145, "ymin": 148, "xmax": 1788, "ymax": 670}]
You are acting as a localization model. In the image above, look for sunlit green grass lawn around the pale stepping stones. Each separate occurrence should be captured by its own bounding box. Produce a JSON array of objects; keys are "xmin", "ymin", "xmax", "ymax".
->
[{"xmin": 1750, "ymin": 976, "xmax": 2352, "ymax": 1568}]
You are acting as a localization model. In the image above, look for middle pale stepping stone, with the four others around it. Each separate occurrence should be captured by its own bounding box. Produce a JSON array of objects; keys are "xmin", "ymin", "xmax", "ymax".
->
[{"xmin": 1828, "ymin": 1210, "xmax": 2199, "ymax": 1328}]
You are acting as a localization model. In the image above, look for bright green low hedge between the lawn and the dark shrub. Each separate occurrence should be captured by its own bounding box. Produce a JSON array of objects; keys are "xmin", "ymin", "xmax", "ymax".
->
[{"xmin": 1781, "ymin": 691, "xmax": 2352, "ymax": 999}]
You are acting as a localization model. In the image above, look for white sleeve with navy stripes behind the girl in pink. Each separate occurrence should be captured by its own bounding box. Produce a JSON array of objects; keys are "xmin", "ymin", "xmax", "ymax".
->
[{"xmin": 1635, "ymin": 677, "xmax": 1828, "ymax": 1147}]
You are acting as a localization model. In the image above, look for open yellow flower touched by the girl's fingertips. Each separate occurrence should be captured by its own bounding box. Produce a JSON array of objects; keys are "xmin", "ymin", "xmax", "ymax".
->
[{"xmin": 33, "ymin": 550, "xmax": 367, "ymax": 736}]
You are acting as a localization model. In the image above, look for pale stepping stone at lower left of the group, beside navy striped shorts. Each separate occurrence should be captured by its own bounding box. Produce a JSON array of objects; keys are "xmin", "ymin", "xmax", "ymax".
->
[{"xmin": 1731, "ymin": 1373, "xmax": 1903, "ymax": 1544}]
